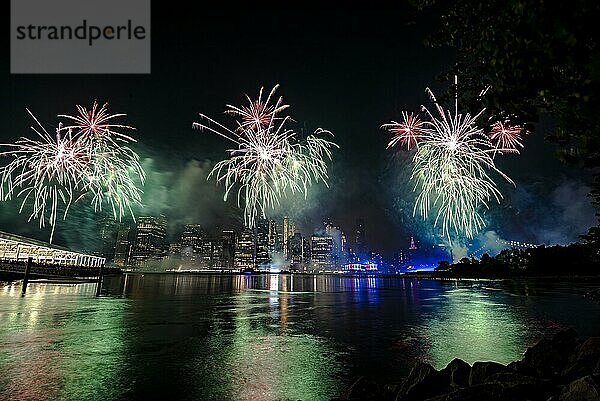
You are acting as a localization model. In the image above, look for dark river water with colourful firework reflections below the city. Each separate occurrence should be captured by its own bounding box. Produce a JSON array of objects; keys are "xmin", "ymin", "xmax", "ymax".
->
[{"xmin": 0, "ymin": 274, "xmax": 600, "ymax": 401}]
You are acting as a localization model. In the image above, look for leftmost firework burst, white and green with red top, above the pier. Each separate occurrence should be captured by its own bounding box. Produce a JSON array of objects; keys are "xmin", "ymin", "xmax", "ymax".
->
[{"xmin": 0, "ymin": 103, "xmax": 144, "ymax": 242}]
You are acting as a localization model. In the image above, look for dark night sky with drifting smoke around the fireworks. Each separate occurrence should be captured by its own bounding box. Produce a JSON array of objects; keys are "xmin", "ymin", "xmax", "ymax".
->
[{"xmin": 0, "ymin": 2, "xmax": 594, "ymax": 253}]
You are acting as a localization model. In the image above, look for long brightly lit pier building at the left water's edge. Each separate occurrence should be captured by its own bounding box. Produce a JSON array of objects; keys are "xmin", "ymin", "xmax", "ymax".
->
[{"xmin": 0, "ymin": 231, "xmax": 106, "ymax": 268}]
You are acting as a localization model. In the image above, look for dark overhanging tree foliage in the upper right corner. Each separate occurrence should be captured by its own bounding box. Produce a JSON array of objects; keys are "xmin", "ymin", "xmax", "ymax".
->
[{"xmin": 415, "ymin": 0, "xmax": 600, "ymax": 166}]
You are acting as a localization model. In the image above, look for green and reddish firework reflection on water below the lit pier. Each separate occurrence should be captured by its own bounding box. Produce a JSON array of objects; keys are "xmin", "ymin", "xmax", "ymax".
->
[{"xmin": 0, "ymin": 284, "xmax": 123, "ymax": 400}]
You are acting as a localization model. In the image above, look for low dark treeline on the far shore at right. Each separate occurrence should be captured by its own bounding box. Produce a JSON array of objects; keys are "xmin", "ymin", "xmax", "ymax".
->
[{"xmin": 435, "ymin": 243, "xmax": 600, "ymax": 277}]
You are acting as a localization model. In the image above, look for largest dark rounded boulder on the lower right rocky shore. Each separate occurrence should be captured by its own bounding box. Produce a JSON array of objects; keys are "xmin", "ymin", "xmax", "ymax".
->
[{"xmin": 513, "ymin": 329, "xmax": 579, "ymax": 380}]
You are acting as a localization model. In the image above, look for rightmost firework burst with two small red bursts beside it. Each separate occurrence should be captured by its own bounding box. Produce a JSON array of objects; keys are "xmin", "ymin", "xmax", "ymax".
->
[{"xmin": 383, "ymin": 78, "xmax": 522, "ymax": 243}]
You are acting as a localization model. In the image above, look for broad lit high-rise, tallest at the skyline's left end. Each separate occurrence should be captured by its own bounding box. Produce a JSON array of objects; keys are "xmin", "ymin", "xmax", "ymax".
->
[{"xmin": 131, "ymin": 215, "xmax": 167, "ymax": 266}]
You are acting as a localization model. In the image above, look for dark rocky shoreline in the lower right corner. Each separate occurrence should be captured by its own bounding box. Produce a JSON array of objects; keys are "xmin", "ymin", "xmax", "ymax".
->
[{"xmin": 332, "ymin": 329, "xmax": 600, "ymax": 401}]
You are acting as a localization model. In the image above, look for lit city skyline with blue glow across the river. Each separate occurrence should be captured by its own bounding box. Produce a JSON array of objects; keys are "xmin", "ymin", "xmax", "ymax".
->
[{"xmin": 92, "ymin": 211, "xmax": 472, "ymax": 274}]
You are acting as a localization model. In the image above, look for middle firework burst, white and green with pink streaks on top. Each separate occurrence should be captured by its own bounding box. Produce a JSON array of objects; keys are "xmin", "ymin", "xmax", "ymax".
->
[{"xmin": 193, "ymin": 86, "xmax": 338, "ymax": 227}]
